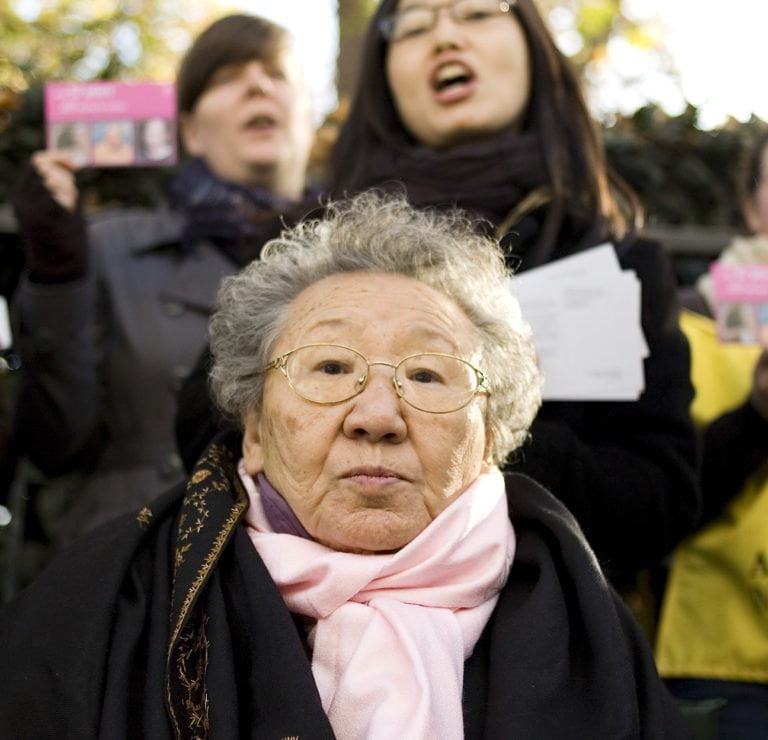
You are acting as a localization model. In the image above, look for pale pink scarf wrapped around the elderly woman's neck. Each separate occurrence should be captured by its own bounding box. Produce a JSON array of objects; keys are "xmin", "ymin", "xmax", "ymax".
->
[{"xmin": 240, "ymin": 463, "xmax": 515, "ymax": 740}]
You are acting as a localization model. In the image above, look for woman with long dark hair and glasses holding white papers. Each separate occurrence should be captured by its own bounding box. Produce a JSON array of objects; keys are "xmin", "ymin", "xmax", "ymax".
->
[{"xmin": 322, "ymin": 0, "xmax": 698, "ymax": 573}]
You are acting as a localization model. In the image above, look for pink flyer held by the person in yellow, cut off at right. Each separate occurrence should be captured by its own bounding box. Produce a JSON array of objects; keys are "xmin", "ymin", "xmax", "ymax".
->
[{"xmin": 710, "ymin": 264, "xmax": 768, "ymax": 346}]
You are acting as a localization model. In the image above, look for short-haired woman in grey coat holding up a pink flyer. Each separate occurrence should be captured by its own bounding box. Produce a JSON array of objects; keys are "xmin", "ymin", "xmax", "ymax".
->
[{"xmin": 9, "ymin": 10, "xmax": 314, "ymax": 541}]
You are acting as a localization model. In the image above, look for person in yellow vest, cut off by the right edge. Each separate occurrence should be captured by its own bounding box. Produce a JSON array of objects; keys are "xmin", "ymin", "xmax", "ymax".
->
[{"xmin": 656, "ymin": 138, "xmax": 768, "ymax": 740}]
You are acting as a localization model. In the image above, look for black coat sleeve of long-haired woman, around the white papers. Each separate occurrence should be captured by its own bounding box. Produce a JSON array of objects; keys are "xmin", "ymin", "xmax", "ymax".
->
[{"xmin": 508, "ymin": 234, "xmax": 699, "ymax": 574}]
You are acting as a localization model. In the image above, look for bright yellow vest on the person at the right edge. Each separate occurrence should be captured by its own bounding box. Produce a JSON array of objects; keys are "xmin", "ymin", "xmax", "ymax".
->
[{"xmin": 656, "ymin": 311, "xmax": 768, "ymax": 683}]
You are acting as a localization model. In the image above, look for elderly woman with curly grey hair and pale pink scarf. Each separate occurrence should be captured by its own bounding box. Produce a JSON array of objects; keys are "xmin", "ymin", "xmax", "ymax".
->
[{"xmin": 0, "ymin": 194, "xmax": 684, "ymax": 740}]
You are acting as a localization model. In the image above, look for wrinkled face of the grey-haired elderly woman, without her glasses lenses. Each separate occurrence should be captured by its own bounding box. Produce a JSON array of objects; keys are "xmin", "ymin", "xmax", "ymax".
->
[{"xmin": 243, "ymin": 273, "xmax": 486, "ymax": 553}]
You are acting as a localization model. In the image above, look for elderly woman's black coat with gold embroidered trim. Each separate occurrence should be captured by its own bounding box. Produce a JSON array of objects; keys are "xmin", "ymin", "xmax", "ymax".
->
[{"xmin": 0, "ymin": 435, "xmax": 686, "ymax": 740}]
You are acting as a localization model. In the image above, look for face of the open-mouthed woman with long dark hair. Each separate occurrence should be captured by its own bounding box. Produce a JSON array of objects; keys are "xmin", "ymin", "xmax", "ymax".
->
[{"xmin": 386, "ymin": 0, "xmax": 530, "ymax": 149}]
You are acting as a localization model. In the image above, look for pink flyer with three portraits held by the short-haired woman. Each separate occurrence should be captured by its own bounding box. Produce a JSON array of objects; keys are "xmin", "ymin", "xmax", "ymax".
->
[{"xmin": 45, "ymin": 81, "xmax": 178, "ymax": 167}]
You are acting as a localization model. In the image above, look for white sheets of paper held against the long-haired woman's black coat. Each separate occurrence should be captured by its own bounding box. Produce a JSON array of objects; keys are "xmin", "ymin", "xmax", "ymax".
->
[{"xmin": 510, "ymin": 244, "xmax": 648, "ymax": 401}]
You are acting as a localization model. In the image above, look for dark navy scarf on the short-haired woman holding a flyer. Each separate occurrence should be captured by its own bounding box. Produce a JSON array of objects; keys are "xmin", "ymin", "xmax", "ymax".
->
[{"xmin": 171, "ymin": 159, "xmax": 295, "ymax": 266}]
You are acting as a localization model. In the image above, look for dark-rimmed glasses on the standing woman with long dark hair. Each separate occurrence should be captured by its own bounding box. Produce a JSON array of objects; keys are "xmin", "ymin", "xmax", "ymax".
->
[{"xmin": 379, "ymin": 0, "xmax": 514, "ymax": 43}]
